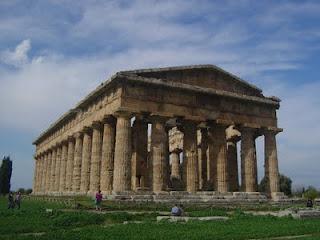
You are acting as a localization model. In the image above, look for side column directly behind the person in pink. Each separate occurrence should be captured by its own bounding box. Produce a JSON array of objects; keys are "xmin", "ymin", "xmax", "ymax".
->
[{"xmin": 90, "ymin": 122, "xmax": 103, "ymax": 193}]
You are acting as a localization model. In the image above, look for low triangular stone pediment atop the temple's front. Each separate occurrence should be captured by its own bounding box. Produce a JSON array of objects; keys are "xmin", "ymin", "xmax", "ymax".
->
[{"xmin": 120, "ymin": 65, "xmax": 263, "ymax": 97}]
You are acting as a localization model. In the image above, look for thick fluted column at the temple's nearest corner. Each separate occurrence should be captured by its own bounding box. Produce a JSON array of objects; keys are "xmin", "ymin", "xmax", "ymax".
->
[{"xmin": 113, "ymin": 113, "xmax": 131, "ymax": 192}]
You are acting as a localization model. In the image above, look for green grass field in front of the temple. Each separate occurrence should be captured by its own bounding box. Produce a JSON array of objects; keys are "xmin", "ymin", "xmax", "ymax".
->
[{"xmin": 0, "ymin": 198, "xmax": 320, "ymax": 240}]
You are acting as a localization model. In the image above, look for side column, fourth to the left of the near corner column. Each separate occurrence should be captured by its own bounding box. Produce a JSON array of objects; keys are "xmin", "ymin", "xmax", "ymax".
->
[{"xmin": 72, "ymin": 132, "xmax": 83, "ymax": 192}]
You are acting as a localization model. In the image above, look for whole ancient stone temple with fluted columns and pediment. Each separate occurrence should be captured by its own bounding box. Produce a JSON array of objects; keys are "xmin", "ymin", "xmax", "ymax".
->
[{"xmin": 33, "ymin": 65, "xmax": 282, "ymax": 201}]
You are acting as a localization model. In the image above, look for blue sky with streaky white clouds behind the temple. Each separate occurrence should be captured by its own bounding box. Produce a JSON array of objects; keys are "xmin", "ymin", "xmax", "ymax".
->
[{"xmin": 0, "ymin": 0, "xmax": 320, "ymax": 189}]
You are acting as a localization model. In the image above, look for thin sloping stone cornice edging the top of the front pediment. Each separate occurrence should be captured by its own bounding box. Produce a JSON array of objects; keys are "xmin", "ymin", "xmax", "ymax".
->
[{"xmin": 119, "ymin": 64, "xmax": 262, "ymax": 93}]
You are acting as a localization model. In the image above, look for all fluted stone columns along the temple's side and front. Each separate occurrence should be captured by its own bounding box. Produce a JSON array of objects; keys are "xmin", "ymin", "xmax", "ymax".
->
[{"xmin": 34, "ymin": 113, "xmax": 279, "ymax": 194}]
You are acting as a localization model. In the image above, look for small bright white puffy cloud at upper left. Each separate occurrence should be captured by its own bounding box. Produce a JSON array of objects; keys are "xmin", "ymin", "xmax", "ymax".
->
[{"xmin": 0, "ymin": 39, "xmax": 31, "ymax": 67}]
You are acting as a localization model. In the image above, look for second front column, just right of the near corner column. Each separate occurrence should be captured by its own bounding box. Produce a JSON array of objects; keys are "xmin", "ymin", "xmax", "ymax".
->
[{"xmin": 151, "ymin": 117, "xmax": 169, "ymax": 193}]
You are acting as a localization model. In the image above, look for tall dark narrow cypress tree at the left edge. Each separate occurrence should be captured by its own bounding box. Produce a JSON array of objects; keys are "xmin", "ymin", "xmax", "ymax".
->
[{"xmin": 0, "ymin": 156, "xmax": 12, "ymax": 195}]
